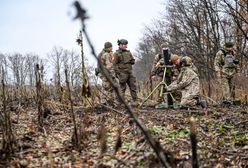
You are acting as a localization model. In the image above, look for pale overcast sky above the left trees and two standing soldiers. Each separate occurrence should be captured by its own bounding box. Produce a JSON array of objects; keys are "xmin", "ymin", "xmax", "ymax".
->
[{"xmin": 0, "ymin": 0, "xmax": 165, "ymax": 64}]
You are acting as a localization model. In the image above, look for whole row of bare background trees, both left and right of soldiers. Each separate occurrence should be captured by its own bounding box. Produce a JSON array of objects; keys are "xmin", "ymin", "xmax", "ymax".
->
[{"xmin": 0, "ymin": 0, "xmax": 248, "ymax": 98}]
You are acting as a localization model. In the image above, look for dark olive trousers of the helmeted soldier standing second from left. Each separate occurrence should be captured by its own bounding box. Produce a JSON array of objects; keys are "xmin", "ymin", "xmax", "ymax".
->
[{"xmin": 118, "ymin": 72, "xmax": 138, "ymax": 101}]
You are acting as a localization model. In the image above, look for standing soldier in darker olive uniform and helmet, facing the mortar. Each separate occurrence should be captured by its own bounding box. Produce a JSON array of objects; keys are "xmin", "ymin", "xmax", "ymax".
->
[{"xmin": 113, "ymin": 39, "xmax": 138, "ymax": 105}]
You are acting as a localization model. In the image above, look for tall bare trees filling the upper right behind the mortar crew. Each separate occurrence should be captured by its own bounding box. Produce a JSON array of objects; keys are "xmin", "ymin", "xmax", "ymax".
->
[{"xmin": 135, "ymin": 0, "xmax": 248, "ymax": 86}]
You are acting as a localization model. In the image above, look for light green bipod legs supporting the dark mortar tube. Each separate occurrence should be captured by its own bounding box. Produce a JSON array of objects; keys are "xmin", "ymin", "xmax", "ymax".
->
[{"xmin": 140, "ymin": 65, "xmax": 176, "ymax": 108}]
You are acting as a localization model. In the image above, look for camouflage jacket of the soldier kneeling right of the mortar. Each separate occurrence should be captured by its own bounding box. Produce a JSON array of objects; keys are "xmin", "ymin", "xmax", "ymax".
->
[{"xmin": 167, "ymin": 66, "xmax": 200, "ymax": 98}]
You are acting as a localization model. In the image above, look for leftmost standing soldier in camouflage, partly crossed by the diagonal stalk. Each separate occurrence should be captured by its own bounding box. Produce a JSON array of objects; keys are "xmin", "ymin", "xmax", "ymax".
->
[{"xmin": 98, "ymin": 42, "xmax": 116, "ymax": 105}]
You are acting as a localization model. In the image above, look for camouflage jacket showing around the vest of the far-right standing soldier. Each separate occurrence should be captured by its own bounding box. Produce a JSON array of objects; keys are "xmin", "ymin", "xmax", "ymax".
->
[{"xmin": 214, "ymin": 50, "xmax": 240, "ymax": 77}]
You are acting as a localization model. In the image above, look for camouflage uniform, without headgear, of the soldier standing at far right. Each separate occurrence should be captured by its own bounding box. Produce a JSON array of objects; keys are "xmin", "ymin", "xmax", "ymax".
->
[{"xmin": 214, "ymin": 45, "xmax": 240, "ymax": 101}]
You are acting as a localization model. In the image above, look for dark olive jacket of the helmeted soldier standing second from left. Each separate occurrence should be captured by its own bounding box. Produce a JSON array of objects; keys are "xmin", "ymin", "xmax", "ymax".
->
[{"xmin": 113, "ymin": 49, "xmax": 135, "ymax": 74}]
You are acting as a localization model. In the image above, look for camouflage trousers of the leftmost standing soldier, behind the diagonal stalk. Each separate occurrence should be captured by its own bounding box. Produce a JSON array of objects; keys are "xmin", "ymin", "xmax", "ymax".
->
[{"xmin": 100, "ymin": 77, "xmax": 116, "ymax": 103}]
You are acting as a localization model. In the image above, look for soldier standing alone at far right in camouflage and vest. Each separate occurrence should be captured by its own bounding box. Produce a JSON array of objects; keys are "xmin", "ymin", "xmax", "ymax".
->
[{"xmin": 214, "ymin": 42, "xmax": 240, "ymax": 104}]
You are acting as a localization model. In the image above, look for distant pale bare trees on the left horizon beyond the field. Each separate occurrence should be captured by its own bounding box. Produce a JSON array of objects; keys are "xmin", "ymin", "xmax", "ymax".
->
[{"xmin": 0, "ymin": 46, "xmax": 93, "ymax": 86}]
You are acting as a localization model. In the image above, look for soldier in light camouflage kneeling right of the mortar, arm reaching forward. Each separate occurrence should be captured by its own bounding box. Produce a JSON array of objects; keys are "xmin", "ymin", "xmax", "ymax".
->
[{"xmin": 166, "ymin": 56, "xmax": 200, "ymax": 107}]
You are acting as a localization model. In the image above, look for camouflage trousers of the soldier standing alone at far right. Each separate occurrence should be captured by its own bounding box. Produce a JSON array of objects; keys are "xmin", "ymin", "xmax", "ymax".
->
[{"xmin": 220, "ymin": 77, "xmax": 234, "ymax": 100}]
